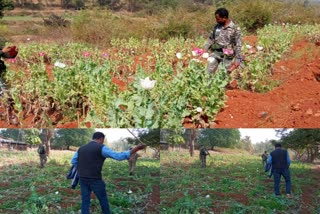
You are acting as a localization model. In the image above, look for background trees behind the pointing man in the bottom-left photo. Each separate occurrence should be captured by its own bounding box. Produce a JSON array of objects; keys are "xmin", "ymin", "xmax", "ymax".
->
[{"xmin": 0, "ymin": 128, "xmax": 160, "ymax": 157}]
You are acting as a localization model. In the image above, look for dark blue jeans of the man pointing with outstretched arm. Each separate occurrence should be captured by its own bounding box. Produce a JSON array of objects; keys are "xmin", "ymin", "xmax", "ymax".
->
[{"xmin": 80, "ymin": 178, "xmax": 111, "ymax": 214}]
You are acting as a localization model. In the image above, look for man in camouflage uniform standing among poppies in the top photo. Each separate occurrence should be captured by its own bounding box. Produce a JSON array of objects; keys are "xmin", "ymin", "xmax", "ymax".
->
[{"xmin": 204, "ymin": 8, "xmax": 242, "ymax": 74}]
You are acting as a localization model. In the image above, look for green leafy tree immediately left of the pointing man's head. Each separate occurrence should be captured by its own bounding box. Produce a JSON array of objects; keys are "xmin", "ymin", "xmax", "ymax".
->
[{"xmin": 53, "ymin": 129, "xmax": 95, "ymax": 150}]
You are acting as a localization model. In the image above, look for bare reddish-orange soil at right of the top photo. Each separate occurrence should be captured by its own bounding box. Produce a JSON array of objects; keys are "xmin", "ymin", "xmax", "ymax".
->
[{"xmin": 215, "ymin": 41, "xmax": 320, "ymax": 128}]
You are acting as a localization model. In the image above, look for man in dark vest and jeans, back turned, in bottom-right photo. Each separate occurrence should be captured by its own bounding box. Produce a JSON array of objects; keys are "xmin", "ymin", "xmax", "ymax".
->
[{"xmin": 267, "ymin": 143, "xmax": 291, "ymax": 198}]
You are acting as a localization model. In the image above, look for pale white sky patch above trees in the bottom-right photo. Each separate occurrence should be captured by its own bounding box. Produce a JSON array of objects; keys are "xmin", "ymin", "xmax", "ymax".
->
[{"xmin": 239, "ymin": 128, "xmax": 279, "ymax": 144}]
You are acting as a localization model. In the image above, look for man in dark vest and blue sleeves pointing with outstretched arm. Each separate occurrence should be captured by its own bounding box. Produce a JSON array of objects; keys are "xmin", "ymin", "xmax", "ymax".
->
[{"xmin": 71, "ymin": 132, "xmax": 146, "ymax": 214}]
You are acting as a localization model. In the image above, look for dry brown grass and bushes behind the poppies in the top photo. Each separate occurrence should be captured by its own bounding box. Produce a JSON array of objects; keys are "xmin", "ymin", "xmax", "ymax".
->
[{"xmin": 0, "ymin": 0, "xmax": 320, "ymax": 47}]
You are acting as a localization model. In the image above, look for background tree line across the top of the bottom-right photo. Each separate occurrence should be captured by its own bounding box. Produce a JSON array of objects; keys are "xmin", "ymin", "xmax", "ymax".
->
[{"xmin": 160, "ymin": 129, "xmax": 320, "ymax": 162}]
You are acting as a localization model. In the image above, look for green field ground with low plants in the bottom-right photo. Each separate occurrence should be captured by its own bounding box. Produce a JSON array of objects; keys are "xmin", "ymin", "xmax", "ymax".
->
[{"xmin": 160, "ymin": 150, "xmax": 317, "ymax": 213}]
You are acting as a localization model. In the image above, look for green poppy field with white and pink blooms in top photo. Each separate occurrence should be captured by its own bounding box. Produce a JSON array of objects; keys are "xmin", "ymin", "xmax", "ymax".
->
[{"xmin": 1, "ymin": 24, "xmax": 319, "ymax": 128}]
